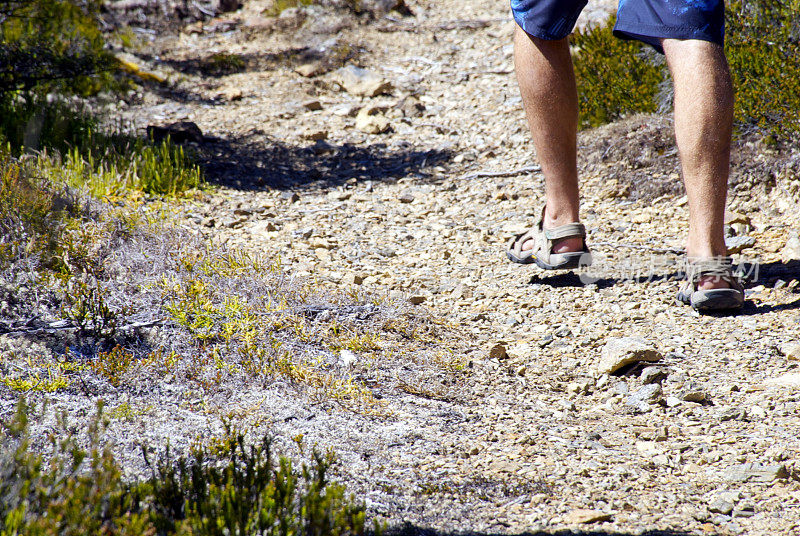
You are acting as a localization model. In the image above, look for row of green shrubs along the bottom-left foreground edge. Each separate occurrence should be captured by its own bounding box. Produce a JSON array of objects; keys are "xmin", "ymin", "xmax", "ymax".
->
[{"xmin": 0, "ymin": 402, "xmax": 372, "ymax": 536}]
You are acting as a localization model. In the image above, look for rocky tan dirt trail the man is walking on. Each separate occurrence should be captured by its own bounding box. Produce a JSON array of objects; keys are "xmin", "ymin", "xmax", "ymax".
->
[{"xmin": 109, "ymin": 0, "xmax": 800, "ymax": 535}]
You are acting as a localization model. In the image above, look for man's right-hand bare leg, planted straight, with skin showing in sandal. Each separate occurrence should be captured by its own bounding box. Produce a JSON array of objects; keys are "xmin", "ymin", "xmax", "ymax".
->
[{"xmin": 662, "ymin": 39, "xmax": 733, "ymax": 290}]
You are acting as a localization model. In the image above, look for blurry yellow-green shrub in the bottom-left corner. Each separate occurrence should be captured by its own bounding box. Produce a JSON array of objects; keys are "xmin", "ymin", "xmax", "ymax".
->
[{"xmin": 0, "ymin": 402, "xmax": 152, "ymax": 536}]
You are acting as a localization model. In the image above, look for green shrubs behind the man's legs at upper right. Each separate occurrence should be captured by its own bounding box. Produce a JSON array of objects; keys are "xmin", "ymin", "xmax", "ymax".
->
[{"xmin": 572, "ymin": 0, "xmax": 800, "ymax": 138}]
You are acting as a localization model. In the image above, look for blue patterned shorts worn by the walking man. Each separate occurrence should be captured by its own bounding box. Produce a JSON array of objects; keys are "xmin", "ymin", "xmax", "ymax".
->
[{"xmin": 511, "ymin": 0, "xmax": 725, "ymax": 52}]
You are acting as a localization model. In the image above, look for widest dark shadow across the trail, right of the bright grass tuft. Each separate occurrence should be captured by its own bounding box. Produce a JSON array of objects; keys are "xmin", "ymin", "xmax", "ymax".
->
[{"xmin": 199, "ymin": 133, "xmax": 453, "ymax": 191}]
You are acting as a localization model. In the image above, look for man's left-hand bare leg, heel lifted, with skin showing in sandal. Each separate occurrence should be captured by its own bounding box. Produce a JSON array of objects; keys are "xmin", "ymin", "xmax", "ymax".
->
[{"xmin": 514, "ymin": 27, "xmax": 583, "ymax": 253}]
